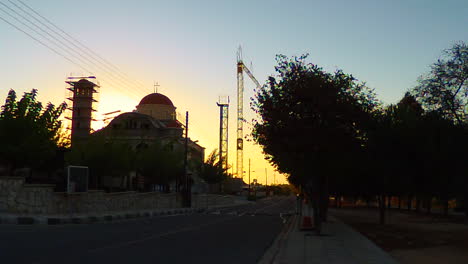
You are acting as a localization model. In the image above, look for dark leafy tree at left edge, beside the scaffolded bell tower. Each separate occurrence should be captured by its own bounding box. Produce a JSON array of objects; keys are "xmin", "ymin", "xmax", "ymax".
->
[{"xmin": 0, "ymin": 89, "xmax": 66, "ymax": 174}]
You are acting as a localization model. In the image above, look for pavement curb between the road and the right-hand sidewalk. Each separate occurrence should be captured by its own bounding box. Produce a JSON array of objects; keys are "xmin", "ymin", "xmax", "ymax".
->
[{"xmin": 257, "ymin": 214, "xmax": 299, "ymax": 264}]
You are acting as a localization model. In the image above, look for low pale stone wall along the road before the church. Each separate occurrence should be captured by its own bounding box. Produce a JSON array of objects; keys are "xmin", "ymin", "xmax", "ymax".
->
[{"xmin": 0, "ymin": 177, "xmax": 235, "ymax": 215}]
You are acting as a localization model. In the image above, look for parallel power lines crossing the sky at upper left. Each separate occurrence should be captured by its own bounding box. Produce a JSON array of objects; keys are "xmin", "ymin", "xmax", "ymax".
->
[{"xmin": 0, "ymin": 0, "xmax": 148, "ymax": 97}]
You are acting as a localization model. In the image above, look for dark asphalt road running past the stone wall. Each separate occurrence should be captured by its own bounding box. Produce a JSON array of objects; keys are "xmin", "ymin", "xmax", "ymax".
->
[{"xmin": 0, "ymin": 197, "xmax": 295, "ymax": 264}]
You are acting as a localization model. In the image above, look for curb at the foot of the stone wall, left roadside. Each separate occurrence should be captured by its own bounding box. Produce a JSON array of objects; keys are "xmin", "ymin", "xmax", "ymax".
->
[{"xmin": 0, "ymin": 208, "xmax": 207, "ymax": 225}]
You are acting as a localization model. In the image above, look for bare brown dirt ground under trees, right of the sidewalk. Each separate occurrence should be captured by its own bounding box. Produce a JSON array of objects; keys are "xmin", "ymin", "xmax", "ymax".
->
[{"xmin": 330, "ymin": 208, "xmax": 468, "ymax": 264}]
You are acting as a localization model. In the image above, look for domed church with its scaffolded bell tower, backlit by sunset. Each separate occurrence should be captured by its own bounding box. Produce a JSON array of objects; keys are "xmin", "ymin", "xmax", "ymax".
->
[{"xmin": 69, "ymin": 79, "xmax": 206, "ymax": 192}]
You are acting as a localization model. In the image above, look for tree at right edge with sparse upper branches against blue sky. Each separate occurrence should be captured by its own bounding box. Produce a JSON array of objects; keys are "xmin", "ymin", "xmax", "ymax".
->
[{"xmin": 412, "ymin": 42, "xmax": 468, "ymax": 213}]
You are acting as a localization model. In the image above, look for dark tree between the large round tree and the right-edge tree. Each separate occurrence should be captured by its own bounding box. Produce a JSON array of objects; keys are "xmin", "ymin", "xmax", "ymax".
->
[{"xmin": 365, "ymin": 93, "xmax": 423, "ymax": 223}]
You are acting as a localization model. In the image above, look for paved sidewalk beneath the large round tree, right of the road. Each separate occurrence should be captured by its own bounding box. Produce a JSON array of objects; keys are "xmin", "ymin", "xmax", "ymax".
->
[{"xmin": 259, "ymin": 215, "xmax": 398, "ymax": 264}]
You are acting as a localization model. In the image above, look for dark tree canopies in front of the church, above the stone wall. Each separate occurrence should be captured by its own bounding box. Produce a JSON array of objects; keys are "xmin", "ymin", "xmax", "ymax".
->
[{"xmin": 66, "ymin": 137, "xmax": 183, "ymax": 190}]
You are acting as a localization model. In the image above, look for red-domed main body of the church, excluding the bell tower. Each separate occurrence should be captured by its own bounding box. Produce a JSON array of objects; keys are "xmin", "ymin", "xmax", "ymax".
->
[{"xmin": 72, "ymin": 90, "xmax": 206, "ymax": 192}]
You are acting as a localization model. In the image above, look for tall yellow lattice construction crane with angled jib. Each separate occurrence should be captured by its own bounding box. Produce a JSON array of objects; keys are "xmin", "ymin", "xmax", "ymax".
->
[{"xmin": 236, "ymin": 47, "xmax": 260, "ymax": 178}]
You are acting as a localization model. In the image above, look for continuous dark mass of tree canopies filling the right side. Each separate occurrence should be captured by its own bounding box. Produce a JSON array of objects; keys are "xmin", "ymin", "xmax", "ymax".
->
[{"xmin": 251, "ymin": 52, "xmax": 468, "ymax": 223}]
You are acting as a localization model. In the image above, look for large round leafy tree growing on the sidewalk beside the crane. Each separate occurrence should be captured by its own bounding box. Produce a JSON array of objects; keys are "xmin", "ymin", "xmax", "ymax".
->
[{"xmin": 251, "ymin": 56, "xmax": 378, "ymax": 231}]
